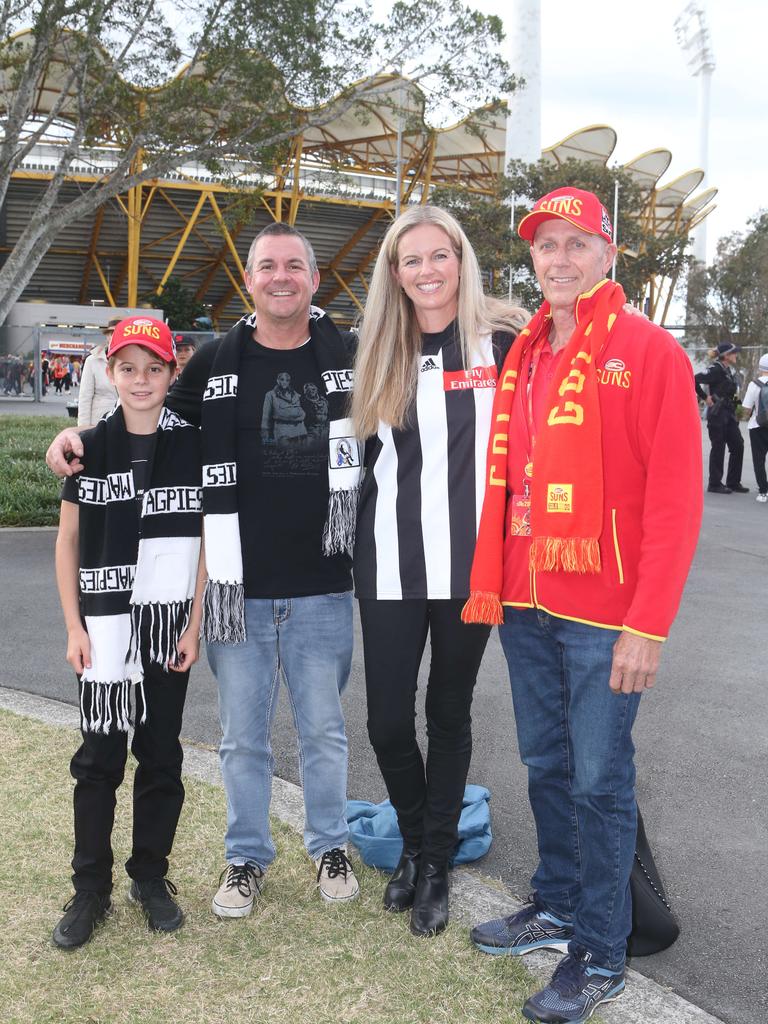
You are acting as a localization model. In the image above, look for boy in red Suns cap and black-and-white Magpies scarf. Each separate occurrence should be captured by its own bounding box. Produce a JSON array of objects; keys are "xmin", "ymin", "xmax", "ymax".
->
[{"xmin": 53, "ymin": 316, "xmax": 205, "ymax": 949}]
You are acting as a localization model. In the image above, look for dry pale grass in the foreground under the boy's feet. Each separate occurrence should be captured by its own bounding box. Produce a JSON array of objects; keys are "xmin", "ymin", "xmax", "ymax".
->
[{"xmin": 0, "ymin": 708, "xmax": 535, "ymax": 1024}]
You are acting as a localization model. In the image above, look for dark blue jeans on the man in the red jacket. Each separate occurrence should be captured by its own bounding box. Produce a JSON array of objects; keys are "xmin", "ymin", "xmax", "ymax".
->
[{"xmin": 499, "ymin": 608, "xmax": 640, "ymax": 971}]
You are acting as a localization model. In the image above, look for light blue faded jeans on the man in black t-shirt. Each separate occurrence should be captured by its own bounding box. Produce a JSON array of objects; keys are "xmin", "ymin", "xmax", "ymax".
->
[{"xmin": 208, "ymin": 591, "xmax": 352, "ymax": 868}]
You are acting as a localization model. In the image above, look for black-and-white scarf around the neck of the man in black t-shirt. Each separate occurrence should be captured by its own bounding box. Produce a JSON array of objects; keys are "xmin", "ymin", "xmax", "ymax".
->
[{"xmin": 202, "ymin": 306, "xmax": 362, "ymax": 643}]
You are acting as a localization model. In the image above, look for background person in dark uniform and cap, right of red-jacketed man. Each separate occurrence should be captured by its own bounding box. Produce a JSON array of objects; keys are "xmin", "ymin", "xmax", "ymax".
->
[{"xmin": 693, "ymin": 341, "xmax": 750, "ymax": 495}]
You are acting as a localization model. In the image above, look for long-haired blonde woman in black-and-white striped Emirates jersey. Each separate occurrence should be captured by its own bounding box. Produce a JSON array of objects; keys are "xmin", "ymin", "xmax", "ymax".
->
[{"xmin": 351, "ymin": 206, "xmax": 527, "ymax": 935}]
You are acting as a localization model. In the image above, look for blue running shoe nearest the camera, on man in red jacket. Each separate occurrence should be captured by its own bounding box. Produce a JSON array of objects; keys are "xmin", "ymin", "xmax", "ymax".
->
[{"xmin": 522, "ymin": 947, "xmax": 624, "ymax": 1024}]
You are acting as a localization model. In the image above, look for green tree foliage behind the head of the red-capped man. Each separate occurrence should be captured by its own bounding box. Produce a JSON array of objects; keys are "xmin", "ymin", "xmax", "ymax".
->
[{"xmin": 432, "ymin": 160, "xmax": 688, "ymax": 309}]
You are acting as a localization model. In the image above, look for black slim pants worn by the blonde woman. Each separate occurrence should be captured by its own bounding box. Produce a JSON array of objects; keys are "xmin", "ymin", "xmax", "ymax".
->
[{"xmin": 359, "ymin": 600, "xmax": 490, "ymax": 864}]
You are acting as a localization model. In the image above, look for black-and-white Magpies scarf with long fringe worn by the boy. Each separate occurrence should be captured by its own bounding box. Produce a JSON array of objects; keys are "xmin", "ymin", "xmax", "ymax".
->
[{"xmin": 78, "ymin": 406, "xmax": 203, "ymax": 732}]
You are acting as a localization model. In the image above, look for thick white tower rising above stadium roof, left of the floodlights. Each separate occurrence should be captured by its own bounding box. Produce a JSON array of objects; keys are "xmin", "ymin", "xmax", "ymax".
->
[{"xmin": 504, "ymin": 0, "xmax": 542, "ymax": 171}]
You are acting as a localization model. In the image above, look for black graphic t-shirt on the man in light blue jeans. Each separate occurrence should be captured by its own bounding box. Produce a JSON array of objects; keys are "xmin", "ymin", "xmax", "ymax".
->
[{"xmin": 166, "ymin": 337, "xmax": 352, "ymax": 598}]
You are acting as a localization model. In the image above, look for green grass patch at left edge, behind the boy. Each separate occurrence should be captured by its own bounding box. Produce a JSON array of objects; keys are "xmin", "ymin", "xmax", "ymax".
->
[{"xmin": 0, "ymin": 416, "xmax": 73, "ymax": 526}]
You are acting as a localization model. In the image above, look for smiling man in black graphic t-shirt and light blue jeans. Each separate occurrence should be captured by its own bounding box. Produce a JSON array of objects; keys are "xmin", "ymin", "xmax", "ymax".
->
[{"xmin": 48, "ymin": 224, "xmax": 358, "ymax": 918}]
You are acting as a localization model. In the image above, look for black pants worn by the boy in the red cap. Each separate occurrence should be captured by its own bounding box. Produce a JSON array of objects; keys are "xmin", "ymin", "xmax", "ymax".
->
[{"xmin": 70, "ymin": 665, "xmax": 189, "ymax": 894}]
